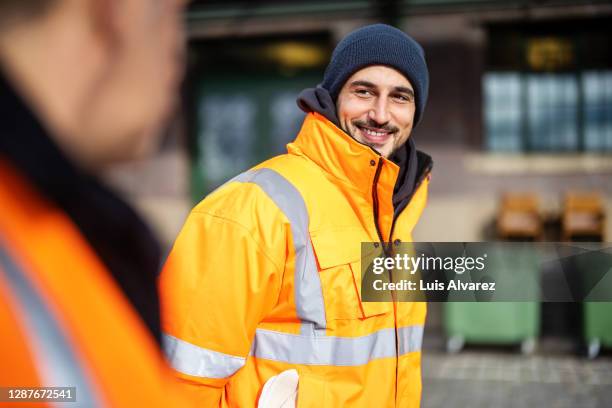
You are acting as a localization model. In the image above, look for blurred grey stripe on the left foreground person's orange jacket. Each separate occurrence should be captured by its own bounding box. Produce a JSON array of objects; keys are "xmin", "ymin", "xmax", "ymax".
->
[{"xmin": 0, "ymin": 241, "xmax": 104, "ymax": 407}]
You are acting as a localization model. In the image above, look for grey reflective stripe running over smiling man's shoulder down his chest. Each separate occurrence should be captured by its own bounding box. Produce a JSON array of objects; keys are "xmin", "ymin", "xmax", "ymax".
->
[{"xmin": 232, "ymin": 169, "xmax": 326, "ymax": 335}]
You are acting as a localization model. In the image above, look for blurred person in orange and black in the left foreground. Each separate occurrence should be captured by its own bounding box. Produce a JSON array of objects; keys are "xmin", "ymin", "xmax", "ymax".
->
[{"xmin": 0, "ymin": 0, "xmax": 191, "ymax": 408}]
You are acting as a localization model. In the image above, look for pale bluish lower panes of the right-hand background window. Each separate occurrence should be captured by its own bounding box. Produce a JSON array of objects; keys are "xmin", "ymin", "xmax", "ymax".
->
[{"xmin": 483, "ymin": 70, "xmax": 612, "ymax": 152}]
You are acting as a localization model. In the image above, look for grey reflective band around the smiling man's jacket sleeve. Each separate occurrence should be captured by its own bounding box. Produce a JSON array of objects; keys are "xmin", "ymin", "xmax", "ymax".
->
[{"xmin": 164, "ymin": 334, "xmax": 246, "ymax": 378}]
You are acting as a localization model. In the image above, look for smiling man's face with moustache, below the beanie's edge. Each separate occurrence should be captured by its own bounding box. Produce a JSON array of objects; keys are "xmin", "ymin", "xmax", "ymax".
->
[{"xmin": 336, "ymin": 65, "xmax": 415, "ymax": 157}]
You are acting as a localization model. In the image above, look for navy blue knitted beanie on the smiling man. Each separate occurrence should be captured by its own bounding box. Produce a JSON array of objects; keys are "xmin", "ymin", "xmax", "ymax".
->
[{"xmin": 321, "ymin": 24, "xmax": 429, "ymax": 126}]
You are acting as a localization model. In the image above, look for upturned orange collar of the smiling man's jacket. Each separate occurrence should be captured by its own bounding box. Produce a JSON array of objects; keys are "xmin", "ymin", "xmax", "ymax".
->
[{"xmin": 287, "ymin": 112, "xmax": 399, "ymax": 205}]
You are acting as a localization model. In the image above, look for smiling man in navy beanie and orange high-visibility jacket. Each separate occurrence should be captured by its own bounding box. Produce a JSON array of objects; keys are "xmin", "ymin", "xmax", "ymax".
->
[{"xmin": 160, "ymin": 24, "xmax": 432, "ymax": 408}]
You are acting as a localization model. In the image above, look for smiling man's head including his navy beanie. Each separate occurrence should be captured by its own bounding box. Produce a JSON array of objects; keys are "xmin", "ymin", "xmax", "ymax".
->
[{"xmin": 321, "ymin": 24, "xmax": 429, "ymax": 157}]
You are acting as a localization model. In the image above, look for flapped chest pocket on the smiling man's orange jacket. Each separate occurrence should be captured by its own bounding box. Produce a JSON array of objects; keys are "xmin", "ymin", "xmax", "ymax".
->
[{"xmin": 311, "ymin": 227, "xmax": 393, "ymax": 320}]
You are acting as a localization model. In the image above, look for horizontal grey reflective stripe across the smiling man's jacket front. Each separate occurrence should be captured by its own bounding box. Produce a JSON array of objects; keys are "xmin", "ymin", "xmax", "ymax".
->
[{"xmin": 251, "ymin": 328, "xmax": 396, "ymax": 366}]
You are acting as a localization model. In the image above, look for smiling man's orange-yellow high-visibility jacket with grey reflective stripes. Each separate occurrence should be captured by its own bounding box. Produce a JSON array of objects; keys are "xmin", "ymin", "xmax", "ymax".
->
[{"xmin": 160, "ymin": 113, "xmax": 428, "ymax": 408}]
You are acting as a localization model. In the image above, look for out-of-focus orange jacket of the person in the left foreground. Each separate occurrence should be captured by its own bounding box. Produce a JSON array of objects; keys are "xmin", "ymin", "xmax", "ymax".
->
[{"xmin": 0, "ymin": 160, "xmax": 187, "ymax": 408}]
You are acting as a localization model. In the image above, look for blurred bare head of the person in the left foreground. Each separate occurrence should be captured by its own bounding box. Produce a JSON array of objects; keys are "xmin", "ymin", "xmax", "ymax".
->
[{"xmin": 0, "ymin": 0, "xmax": 185, "ymax": 167}]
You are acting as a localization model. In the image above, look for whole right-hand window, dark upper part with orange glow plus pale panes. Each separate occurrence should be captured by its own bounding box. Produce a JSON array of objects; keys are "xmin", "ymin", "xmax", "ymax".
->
[{"xmin": 482, "ymin": 18, "xmax": 612, "ymax": 152}]
